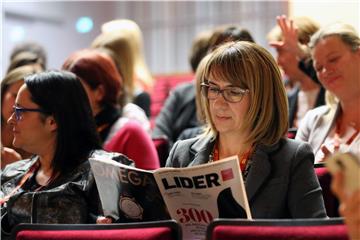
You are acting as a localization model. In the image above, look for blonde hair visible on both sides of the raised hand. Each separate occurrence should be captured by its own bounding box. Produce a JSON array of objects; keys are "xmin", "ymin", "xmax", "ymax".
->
[{"xmin": 267, "ymin": 16, "xmax": 320, "ymax": 44}]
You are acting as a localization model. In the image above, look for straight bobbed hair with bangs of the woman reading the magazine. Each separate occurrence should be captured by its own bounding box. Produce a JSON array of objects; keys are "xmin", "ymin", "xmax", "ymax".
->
[{"xmin": 196, "ymin": 41, "xmax": 288, "ymax": 145}]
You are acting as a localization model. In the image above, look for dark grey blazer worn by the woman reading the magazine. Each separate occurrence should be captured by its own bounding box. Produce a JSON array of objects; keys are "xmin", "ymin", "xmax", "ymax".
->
[{"xmin": 166, "ymin": 136, "xmax": 326, "ymax": 218}]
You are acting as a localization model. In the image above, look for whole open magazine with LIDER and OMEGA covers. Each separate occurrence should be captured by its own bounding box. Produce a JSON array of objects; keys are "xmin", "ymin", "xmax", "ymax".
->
[{"xmin": 90, "ymin": 156, "xmax": 251, "ymax": 239}]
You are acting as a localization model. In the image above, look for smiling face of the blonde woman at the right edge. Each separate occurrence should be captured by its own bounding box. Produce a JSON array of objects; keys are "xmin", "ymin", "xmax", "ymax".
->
[{"xmin": 312, "ymin": 36, "xmax": 360, "ymax": 100}]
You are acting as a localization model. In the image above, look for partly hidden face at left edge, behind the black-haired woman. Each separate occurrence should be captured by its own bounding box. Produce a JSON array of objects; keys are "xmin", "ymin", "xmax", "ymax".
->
[{"xmin": 1, "ymin": 80, "xmax": 24, "ymax": 122}]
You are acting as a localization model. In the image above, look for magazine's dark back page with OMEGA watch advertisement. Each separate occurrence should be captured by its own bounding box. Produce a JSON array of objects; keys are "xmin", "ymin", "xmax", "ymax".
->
[{"xmin": 90, "ymin": 158, "xmax": 170, "ymax": 222}]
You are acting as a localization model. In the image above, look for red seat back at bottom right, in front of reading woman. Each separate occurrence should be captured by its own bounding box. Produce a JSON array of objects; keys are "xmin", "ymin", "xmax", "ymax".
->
[{"xmin": 206, "ymin": 218, "xmax": 348, "ymax": 240}]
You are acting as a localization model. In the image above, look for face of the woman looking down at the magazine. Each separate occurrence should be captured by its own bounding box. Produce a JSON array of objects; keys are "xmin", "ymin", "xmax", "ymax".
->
[{"xmin": 209, "ymin": 77, "xmax": 250, "ymax": 137}]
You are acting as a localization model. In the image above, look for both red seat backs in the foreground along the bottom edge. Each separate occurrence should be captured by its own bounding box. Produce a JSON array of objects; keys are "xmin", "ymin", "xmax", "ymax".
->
[{"xmin": 12, "ymin": 218, "xmax": 348, "ymax": 240}]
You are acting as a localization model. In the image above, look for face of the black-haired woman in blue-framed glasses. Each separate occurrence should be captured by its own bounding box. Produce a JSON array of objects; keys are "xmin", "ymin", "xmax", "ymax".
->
[{"xmin": 8, "ymin": 85, "xmax": 56, "ymax": 154}]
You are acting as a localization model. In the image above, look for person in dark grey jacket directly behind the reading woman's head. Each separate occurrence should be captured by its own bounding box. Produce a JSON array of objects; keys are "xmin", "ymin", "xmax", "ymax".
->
[{"xmin": 152, "ymin": 25, "xmax": 254, "ymax": 146}]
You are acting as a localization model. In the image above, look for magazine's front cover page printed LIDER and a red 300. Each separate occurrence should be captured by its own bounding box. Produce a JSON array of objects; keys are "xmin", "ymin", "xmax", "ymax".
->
[{"xmin": 154, "ymin": 156, "xmax": 251, "ymax": 239}]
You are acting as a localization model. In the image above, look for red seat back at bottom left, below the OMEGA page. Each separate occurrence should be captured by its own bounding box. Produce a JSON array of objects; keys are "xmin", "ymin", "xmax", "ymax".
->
[{"xmin": 11, "ymin": 220, "xmax": 182, "ymax": 240}]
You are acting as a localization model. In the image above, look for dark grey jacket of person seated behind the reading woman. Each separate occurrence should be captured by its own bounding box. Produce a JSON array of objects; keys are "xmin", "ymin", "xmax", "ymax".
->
[{"xmin": 152, "ymin": 82, "xmax": 199, "ymax": 147}]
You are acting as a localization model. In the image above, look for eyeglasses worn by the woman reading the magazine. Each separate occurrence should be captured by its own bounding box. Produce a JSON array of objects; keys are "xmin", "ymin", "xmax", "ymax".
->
[{"xmin": 200, "ymin": 83, "xmax": 249, "ymax": 103}]
